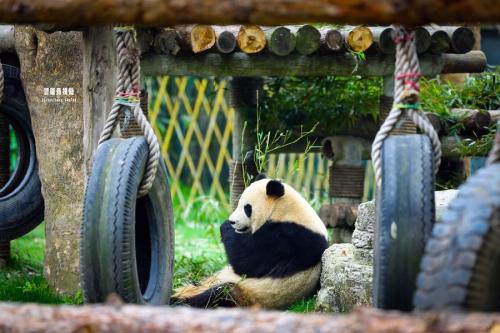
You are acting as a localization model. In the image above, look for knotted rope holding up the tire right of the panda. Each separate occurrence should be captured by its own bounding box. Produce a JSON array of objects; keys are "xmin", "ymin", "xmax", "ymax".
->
[{"xmin": 372, "ymin": 27, "xmax": 441, "ymax": 187}]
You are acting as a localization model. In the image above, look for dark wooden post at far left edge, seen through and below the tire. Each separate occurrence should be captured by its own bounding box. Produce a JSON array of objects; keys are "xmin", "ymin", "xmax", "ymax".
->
[{"xmin": 0, "ymin": 113, "xmax": 10, "ymax": 268}]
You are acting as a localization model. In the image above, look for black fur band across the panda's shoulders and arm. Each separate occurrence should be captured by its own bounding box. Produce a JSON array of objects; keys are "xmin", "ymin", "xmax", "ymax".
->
[{"xmin": 221, "ymin": 221, "xmax": 328, "ymax": 278}]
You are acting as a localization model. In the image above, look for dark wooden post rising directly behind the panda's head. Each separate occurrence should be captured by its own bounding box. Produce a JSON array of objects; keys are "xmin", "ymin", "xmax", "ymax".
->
[{"xmin": 230, "ymin": 77, "xmax": 263, "ymax": 209}]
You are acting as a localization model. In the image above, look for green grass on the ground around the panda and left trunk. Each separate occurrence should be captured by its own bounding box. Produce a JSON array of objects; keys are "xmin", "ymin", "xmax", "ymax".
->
[{"xmin": 0, "ymin": 193, "xmax": 315, "ymax": 312}]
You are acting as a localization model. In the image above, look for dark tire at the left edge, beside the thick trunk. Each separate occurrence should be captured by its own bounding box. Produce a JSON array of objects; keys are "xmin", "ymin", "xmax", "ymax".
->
[{"xmin": 0, "ymin": 65, "xmax": 44, "ymax": 241}]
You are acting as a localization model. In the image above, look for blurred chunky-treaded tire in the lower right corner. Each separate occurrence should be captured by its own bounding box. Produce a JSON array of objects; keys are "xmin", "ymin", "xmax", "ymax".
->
[{"xmin": 414, "ymin": 163, "xmax": 500, "ymax": 311}]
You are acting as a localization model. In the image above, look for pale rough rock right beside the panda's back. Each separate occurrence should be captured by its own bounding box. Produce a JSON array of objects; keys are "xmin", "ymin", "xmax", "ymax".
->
[{"xmin": 316, "ymin": 244, "xmax": 373, "ymax": 312}]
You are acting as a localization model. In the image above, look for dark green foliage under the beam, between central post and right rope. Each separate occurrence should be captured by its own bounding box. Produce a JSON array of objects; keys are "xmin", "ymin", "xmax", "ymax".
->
[{"xmin": 262, "ymin": 76, "xmax": 382, "ymax": 132}]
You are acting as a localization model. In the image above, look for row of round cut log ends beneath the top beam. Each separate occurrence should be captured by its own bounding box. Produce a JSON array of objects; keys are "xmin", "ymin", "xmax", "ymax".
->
[{"xmin": 139, "ymin": 24, "xmax": 475, "ymax": 56}]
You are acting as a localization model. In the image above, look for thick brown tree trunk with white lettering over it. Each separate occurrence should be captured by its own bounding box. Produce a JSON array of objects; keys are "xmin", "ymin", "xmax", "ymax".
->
[{"xmin": 15, "ymin": 27, "xmax": 85, "ymax": 294}]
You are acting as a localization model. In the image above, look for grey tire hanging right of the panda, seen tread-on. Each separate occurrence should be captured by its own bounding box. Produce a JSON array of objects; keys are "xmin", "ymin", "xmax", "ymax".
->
[{"xmin": 373, "ymin": 135, "xmax": 435, "ymax": 311}]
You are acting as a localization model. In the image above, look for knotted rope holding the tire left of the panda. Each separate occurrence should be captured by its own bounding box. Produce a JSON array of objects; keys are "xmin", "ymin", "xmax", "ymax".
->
[{"xmin": 99, "ymin": 27, "xmax": 160, "ymax": 197}]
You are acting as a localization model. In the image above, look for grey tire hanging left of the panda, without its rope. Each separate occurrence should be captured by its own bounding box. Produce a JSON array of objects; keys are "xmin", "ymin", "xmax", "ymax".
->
[{"xmin": 80, "ymin": 137, "xmax": 174, "ymax": 305}]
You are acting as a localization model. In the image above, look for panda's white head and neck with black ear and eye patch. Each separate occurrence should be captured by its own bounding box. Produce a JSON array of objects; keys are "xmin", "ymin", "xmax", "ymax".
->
[{"xmin": 229, "ymin": 175, "xmax": 326, "ymax": 234}]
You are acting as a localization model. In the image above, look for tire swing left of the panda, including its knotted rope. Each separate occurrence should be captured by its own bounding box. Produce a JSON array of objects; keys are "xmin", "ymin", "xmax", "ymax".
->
[{"xmin": 80, "ymin": 27, "xmax": 174, "ymax": 305}]
